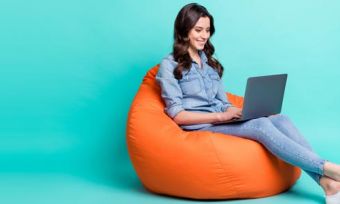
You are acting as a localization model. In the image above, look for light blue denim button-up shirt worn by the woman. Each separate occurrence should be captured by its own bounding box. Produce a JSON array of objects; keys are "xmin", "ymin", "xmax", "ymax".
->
[{"xmin": 156, "ymin": 51, "xmax": 232, "ymax": 130}]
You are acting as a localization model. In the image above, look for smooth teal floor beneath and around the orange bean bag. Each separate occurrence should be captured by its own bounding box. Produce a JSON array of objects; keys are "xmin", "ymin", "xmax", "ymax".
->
[{"xmin": 0, "ymin": 173, "xmax": 324, "ymax": 204}]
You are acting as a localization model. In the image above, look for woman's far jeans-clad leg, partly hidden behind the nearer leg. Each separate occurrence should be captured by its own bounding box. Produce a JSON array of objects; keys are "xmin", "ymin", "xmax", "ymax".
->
[{"xmin": 268, "ymin": 114, "xmax": 321, "ymax": 184}]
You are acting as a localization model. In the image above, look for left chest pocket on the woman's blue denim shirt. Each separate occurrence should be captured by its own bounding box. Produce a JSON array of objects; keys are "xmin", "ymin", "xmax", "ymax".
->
[{"xmin": 179, "ymin": 75, "xmax": 202, "ymax": 96}]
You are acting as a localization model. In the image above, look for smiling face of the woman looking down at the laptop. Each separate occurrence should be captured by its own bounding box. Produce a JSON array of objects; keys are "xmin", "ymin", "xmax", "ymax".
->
[{"xmin": 188, "ymin": 17, "xmax": 210, "ymax": 51}]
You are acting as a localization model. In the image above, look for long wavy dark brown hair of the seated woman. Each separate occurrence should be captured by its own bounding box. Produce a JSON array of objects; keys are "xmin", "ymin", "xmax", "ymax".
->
[{"xmin": 173, "ymin": 3, "xmax": 223, "ymax": 79}]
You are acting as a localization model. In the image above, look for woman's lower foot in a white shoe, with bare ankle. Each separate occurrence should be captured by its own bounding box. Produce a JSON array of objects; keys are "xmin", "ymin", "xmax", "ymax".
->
[{"xmin": 320, "ymin": 176, "xmax": 340, "ymax": 204}]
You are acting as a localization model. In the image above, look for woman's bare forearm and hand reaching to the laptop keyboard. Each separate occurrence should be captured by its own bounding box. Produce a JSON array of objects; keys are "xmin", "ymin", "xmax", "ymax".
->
[{"xmin": 173, "ymin": 107, "xmax": 242, "ymax": 125}]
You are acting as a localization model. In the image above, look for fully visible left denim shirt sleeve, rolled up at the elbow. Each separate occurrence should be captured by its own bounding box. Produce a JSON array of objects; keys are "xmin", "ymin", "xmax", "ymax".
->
[{"xmin": 156, "ymin": 58, "xmax": 184, "ymax": 118}]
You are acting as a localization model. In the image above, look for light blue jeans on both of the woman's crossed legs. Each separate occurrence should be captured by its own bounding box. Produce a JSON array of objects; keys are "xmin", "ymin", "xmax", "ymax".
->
[{"xmin": 200, "ymin": 114, "xmax": 326, "ymax": 184}]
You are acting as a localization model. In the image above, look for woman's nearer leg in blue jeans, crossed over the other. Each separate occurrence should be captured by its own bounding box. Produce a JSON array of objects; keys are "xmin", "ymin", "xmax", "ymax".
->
[{"xmin": 202, "ymin": 118, "xmax": 325, "ymax": 178}]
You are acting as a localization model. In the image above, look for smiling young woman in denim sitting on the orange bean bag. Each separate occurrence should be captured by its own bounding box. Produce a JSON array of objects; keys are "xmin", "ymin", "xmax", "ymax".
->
[{"xmin": 156, "ymin": 3, "xmax": 340, "ymax": 204}]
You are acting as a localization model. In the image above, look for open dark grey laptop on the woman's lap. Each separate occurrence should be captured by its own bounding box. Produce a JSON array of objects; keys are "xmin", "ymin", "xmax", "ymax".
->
[{"xmin": 226, "ymin": 74, "xmax": 288, "ymax": 123}]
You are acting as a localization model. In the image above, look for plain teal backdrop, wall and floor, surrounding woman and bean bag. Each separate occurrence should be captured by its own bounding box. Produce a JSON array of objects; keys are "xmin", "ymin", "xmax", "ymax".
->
[{"xmin": 0, "ymin": 0, "xmax": 340, "ymax": 203}]
